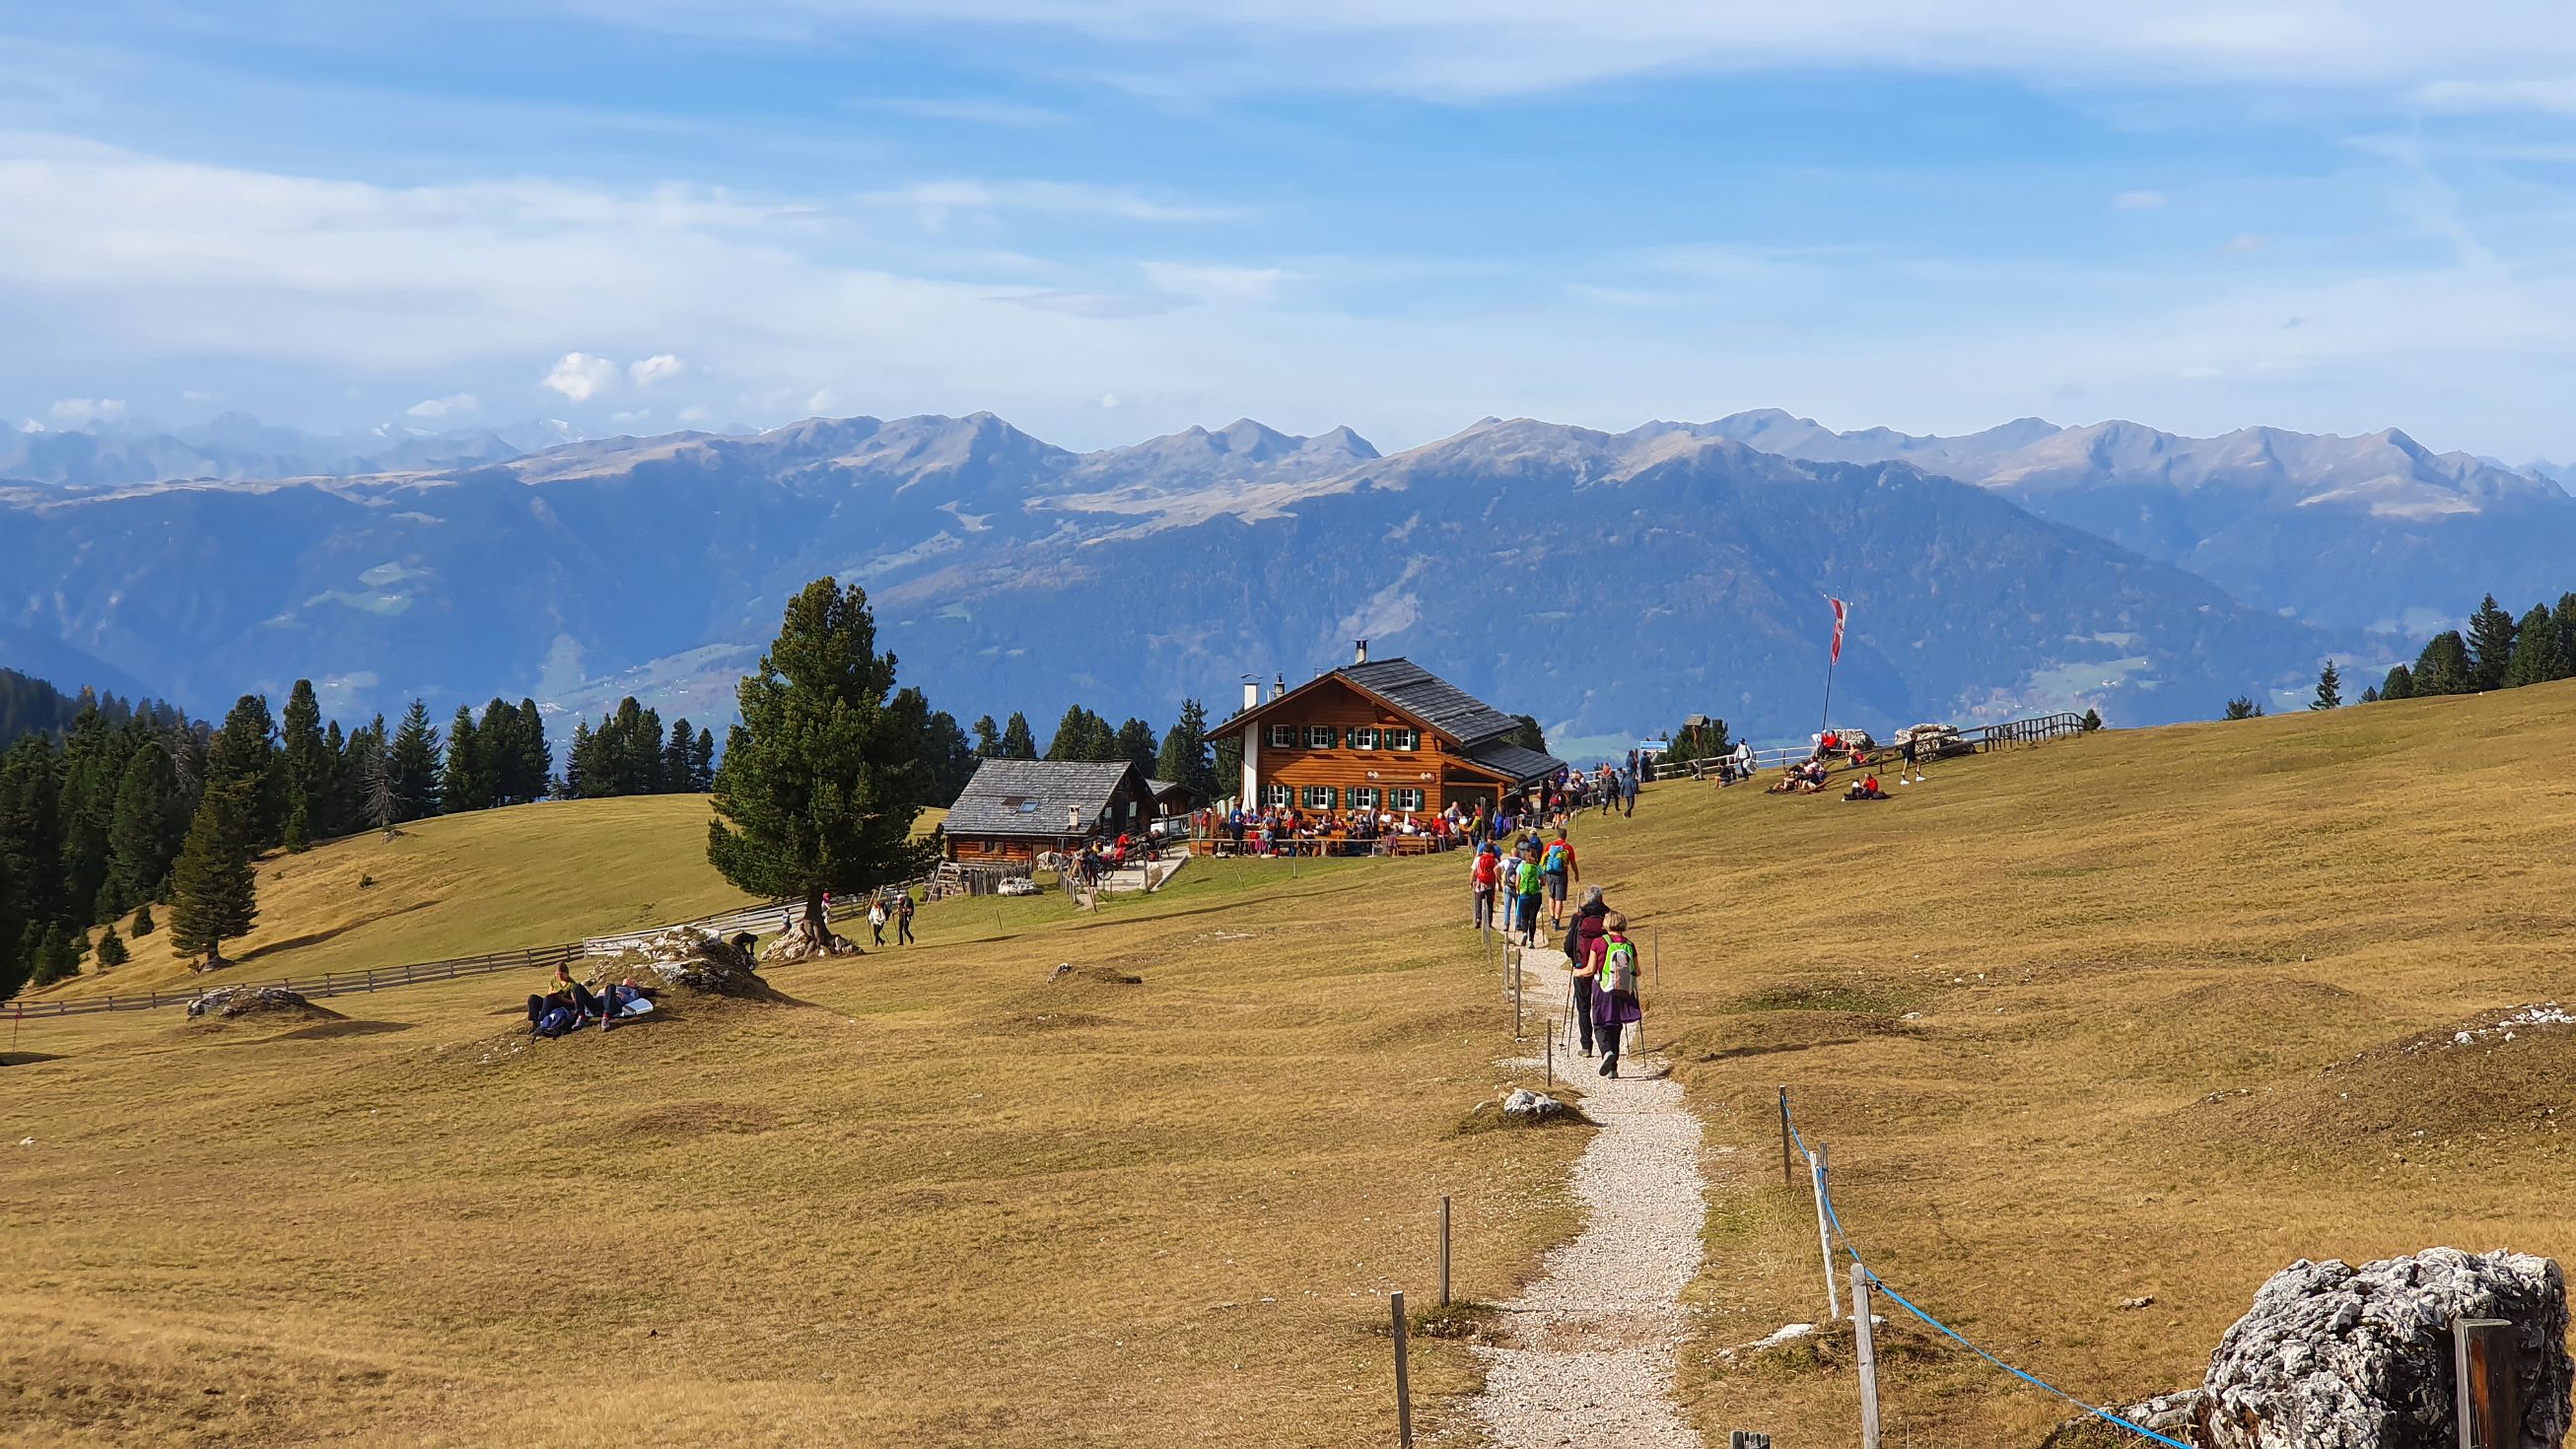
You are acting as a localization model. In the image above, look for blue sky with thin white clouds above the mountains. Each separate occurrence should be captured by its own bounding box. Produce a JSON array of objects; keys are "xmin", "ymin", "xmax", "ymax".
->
[{"xmin": 0, "ymin": 0, "xmax": 2576, "ymax": 460}]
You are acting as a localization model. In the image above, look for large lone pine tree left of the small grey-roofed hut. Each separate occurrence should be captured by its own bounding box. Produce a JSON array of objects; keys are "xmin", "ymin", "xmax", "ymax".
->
[{"xmin": 706, "ymin": 579, "xmax": 930, "ymax": 932}]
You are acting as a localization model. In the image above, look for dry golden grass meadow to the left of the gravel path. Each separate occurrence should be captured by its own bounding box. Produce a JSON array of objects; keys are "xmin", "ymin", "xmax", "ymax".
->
[{"xmin": 0, "ymin": 862, "xmax": 1587, "ymax": 1446}]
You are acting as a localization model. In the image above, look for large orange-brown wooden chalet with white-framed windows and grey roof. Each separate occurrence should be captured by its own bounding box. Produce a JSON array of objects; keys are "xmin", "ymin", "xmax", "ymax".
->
[{"xmin": 1211, "ymin": 644, "xmax": 1566, "ymax": 816}]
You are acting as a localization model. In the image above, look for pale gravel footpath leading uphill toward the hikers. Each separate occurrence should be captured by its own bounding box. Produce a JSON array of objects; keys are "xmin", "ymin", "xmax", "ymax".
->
[{"xmin": 1471, "ymin": 949, "xmax": 1707, "ymax": 1449}]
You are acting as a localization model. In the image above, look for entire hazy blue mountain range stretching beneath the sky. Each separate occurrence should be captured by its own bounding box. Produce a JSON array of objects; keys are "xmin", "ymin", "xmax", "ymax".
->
[{"xmin": 15, "ymin": 401, "xmax": 2493, "ymax": 746}]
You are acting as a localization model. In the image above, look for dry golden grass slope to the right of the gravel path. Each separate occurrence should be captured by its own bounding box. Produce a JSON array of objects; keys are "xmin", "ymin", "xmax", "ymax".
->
[{"xmin": 1584, "ymin": 685, "xmax": 2576, "ymax": 1444}]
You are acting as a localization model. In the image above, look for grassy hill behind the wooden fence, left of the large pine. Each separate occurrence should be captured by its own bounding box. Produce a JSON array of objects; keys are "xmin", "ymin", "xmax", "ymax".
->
[{"xmin": 29, "ymin": 795, "xmax": 749, "ymax": 999}]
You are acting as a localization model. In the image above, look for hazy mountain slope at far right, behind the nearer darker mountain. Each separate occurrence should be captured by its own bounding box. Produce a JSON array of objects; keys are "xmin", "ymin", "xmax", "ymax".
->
[{"xmin": 1700, "ymin": 409, "xmax": 2576, "ymax": 633}]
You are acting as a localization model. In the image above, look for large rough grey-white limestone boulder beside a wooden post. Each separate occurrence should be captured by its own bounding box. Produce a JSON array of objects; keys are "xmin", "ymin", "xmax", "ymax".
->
[{"xmin": 2200, "ymin": 1248, "xmax": 2576, "ymax": 1449}]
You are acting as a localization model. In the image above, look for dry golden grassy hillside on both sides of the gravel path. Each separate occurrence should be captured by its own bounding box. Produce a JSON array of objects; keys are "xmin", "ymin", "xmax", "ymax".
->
[{"xmin": 15, "ymin": 685, "xmax": 2576, "ymax": 1446}]
